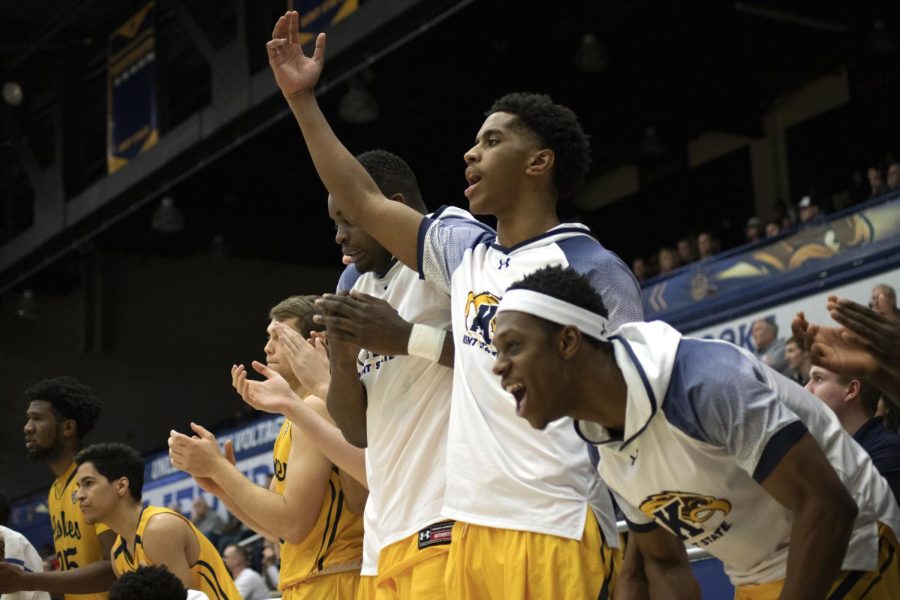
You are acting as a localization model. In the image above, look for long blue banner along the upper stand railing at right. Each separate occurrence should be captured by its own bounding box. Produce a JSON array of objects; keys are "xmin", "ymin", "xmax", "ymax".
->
[{"xmin": 642, "ymin": 194, "xmax": 900, "ymax": 329}]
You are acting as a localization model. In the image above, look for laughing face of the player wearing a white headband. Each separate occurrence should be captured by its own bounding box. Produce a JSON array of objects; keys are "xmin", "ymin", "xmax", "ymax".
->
[{"xmin": 493, "ymin": 311, "xmax": 572, "ymax": 429}]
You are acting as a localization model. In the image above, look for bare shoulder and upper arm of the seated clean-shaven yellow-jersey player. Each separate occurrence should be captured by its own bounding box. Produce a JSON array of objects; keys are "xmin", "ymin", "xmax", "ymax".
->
[{"xmin": 141, "ymin": 513, "xmax": 200, "ymax": 589}]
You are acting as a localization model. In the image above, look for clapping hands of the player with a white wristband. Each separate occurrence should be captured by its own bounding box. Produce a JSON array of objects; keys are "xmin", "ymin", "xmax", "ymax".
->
[{"xmin": 315, "ymin": 291, "xmax": 412, "ymax": 356}]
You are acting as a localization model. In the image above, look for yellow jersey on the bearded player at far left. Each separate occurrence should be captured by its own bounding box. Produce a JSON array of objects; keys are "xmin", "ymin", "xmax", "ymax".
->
[{"xmin": 47, "ymin": 462, "xmax": 109, "ymax": 600}]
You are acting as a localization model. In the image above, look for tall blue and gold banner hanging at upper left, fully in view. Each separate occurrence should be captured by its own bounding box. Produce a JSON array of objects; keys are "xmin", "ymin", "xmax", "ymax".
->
[{"xmin": 106, "ymin": 2, "xmax": 159, "ymax": 173}]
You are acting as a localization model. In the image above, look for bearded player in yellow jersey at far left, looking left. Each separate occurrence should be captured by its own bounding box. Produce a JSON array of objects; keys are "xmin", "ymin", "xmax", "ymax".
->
[{"xmin": 0, "ymin": 376, "xmax": 115, "ymax": 600}]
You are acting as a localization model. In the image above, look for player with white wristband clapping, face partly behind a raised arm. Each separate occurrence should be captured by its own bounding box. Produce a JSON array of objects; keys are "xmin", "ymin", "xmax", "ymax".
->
[{"xmin": 241, "ymin": 150, "xmax": 453, "ymax": 599}]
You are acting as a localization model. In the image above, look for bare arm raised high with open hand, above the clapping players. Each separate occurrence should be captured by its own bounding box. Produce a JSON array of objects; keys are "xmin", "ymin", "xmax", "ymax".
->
[{"xmin": 266, "ymin": 11, "xmax": 423, "ymax": 269}]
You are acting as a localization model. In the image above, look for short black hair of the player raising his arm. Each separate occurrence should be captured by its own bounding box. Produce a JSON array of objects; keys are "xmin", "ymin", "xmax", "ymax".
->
[{"xmin": 487, "ymin": 92, "xmax": 591, "ymax": 198}]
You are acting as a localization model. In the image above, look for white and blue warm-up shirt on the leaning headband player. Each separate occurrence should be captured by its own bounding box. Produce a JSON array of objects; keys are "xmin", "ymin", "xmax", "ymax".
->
[{"xmin": 576, "ymin": 321, "xmax": 900, "ymax": 586}]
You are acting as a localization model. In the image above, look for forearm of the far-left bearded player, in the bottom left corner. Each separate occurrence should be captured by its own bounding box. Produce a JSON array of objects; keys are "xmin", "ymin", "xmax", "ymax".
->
[{"xmin": 0, "ymin": 560, "xmax": 116, "ymax": 594}]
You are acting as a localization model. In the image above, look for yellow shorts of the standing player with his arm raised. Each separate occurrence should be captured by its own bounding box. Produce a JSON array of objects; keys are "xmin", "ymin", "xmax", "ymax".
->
[{"xmin": 445, "ymin": 508, "xmax": 622, "ymax": 600}]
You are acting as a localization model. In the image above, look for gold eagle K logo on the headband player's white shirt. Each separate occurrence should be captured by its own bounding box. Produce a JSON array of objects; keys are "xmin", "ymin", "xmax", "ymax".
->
[{"xmin": 640, "ymin": 491, "xmax": 731, "ymax": 542}]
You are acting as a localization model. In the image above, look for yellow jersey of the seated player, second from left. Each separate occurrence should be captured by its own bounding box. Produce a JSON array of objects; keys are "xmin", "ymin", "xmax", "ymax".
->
[{"xmin": 113, "ymin": 506, "xmax": 241, "ymax": 600}]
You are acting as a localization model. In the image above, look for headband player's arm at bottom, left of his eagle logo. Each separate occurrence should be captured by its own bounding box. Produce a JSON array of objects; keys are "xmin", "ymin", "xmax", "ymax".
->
[{"xmin": 613, "ymin": 526, "xmax": 700, "ymax": 600}]
